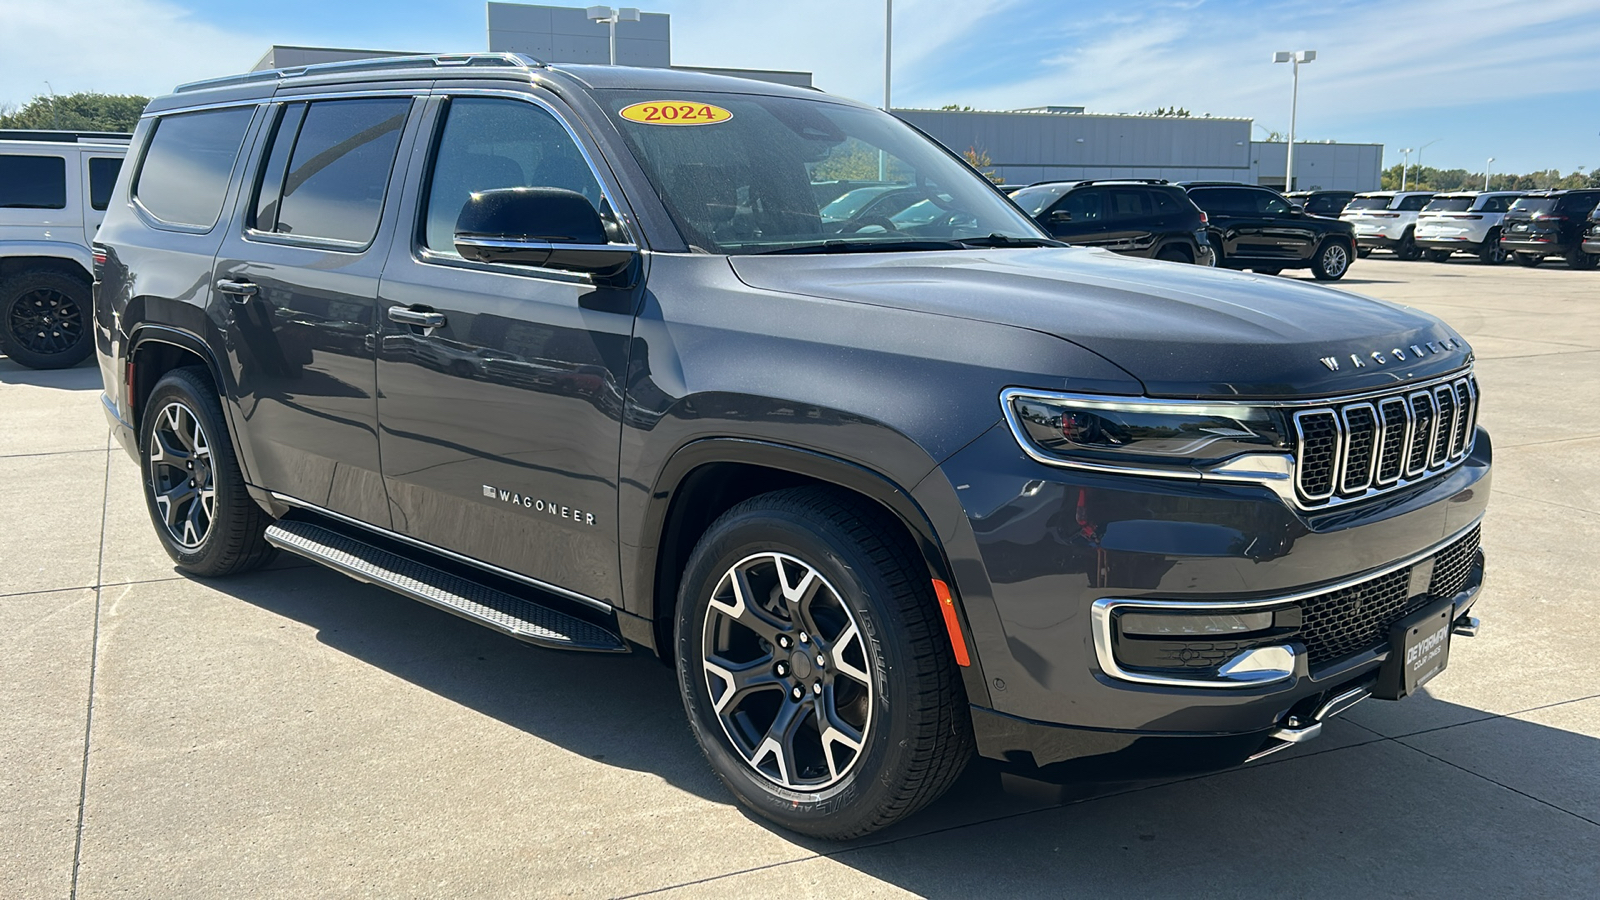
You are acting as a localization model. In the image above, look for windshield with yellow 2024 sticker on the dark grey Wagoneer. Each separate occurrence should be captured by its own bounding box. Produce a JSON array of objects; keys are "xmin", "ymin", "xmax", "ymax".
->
[{"xmin": 598, "ymin": 90, "xmax": 1048, "ymax": 253}]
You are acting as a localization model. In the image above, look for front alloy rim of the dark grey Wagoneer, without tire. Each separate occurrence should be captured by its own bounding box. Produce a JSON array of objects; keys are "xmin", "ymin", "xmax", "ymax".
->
[{"xmin": 701, "ymin": 552, "xmax": 874, "ymax": 793}]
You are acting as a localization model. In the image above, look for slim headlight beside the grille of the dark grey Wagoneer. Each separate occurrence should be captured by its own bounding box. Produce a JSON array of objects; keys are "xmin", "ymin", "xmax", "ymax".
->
[{"xmin": 1003, "ymin": 389, "xmax": 1290, "ymax": 468}]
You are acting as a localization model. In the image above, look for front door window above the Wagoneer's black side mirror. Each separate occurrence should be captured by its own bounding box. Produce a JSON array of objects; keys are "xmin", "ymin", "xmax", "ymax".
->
[{"xmin": 422, "ymin": 98, "xmax": 601, "ymax": 255}]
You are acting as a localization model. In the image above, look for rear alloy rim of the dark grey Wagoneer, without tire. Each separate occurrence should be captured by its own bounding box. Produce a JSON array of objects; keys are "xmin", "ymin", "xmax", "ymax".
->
[{"xmin": 149, "ymin": 402, "xmax": 216, "ymax": 551}]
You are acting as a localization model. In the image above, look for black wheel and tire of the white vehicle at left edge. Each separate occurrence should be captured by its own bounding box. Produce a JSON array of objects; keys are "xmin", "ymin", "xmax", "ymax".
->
[{"xmin": 0, "ymin": 269, "xmax": 94, "ymax": 368}]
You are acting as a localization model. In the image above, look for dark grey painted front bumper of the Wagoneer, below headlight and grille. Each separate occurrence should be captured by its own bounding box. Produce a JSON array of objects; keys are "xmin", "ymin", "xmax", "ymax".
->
[{"xmin": 918, "ymin": 428, "xmax": 1493, "ymax": 767}]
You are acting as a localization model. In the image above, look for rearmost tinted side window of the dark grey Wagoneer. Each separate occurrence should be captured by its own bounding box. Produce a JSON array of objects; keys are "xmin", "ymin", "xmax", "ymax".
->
[{"xmin": 133, "ymin": 106, "xmax": 256, "ymax": 227}]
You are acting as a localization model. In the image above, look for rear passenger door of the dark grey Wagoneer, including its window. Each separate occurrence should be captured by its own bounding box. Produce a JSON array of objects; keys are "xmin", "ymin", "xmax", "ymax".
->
[{"xmin": 213, "ymin": 88, "xmax": 422, "ymax": 527}]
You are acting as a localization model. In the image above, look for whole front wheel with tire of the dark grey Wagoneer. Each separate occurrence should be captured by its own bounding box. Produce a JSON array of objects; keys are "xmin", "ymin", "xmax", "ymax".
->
[{"xmin": 677, "ymin": 488, "xmax": 973, "ymax": 841}]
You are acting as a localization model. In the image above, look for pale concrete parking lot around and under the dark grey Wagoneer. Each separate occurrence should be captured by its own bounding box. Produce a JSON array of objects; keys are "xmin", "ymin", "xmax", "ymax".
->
[{"xmin": 0, "ymin": 253, "xmax": 1600, "ymax": 900}]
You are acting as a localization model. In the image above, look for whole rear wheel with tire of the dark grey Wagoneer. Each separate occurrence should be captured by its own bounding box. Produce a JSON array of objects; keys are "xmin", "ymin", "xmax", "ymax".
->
[{"xmin": 139, "ymin": 368, "xmax": 275, "ymax": 577}]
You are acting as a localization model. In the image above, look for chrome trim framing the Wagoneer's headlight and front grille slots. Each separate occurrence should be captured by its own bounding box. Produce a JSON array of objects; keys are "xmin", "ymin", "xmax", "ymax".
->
[{"xmin": 1000, "ymin": 367, "xmax": 1477, "ymax": 512}]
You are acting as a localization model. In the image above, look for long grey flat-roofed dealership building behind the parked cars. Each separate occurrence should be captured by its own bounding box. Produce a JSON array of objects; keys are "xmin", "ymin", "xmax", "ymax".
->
[{"xmin": 256, "ymin": 3, "xmax": 1384, "ymax": 191}]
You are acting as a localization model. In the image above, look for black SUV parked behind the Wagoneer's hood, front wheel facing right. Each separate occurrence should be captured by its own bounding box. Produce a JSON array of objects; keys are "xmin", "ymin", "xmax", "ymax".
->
[{"xmin": 1184, "ymin": 181, "xmax": 1355, "ymax": 282}]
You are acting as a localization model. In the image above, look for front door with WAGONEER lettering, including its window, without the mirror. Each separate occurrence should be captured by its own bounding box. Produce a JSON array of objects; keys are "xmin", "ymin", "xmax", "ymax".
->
[{"xmin": 378, "ymin": 94, "xmax": 634, "ymax": 602}]
